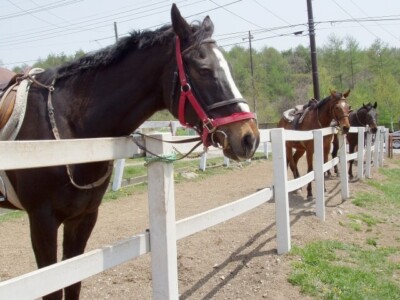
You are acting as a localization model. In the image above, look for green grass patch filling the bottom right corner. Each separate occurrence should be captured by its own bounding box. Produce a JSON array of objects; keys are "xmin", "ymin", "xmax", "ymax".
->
[{"xmin": 288, "ymin": 241, "xmax": 400, "ymax": 300}]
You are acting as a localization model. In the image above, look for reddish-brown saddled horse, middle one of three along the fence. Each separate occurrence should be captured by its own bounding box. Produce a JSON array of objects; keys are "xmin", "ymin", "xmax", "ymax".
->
[{"xmin": 278, "ymin": 90, "xmax": 350, "ymax": 198}]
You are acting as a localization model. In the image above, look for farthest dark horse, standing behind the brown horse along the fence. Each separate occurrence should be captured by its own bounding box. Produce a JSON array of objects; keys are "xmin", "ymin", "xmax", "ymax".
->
[{"xmin": 332, "ymin": 102, "xmax": 378, "ymax": 178}]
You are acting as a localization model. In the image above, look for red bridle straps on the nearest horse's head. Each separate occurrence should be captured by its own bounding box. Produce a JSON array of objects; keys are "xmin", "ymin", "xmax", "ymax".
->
[{"xmin": 176, "ymin": 37, "xmax": 256, "ymax": 147}]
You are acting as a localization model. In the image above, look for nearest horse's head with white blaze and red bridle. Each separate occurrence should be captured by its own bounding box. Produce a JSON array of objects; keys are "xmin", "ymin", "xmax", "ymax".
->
[{"xmin": 171, "ymin": 5, "xmax": 259, "ymax": 160}]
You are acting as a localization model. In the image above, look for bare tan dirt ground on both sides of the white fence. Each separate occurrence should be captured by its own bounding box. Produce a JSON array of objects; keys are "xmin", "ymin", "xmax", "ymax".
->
[{"xmin": 0, "ymin": 156, "xmax": 400, "ymax": 300}]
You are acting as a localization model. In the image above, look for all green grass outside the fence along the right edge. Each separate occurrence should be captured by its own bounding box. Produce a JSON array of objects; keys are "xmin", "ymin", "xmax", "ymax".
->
[{"xmin": 288, "ymin": 162, "xmax": 400, "ymax": 300}]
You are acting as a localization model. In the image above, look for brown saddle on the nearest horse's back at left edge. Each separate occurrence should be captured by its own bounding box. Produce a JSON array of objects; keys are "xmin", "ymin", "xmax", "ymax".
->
[{"xmin": 0, "ymin": 67, "xmax": 24, "ymax": 129}]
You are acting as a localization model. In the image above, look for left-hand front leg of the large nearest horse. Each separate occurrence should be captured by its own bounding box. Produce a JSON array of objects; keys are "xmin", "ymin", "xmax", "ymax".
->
[{"xmin": 28, "ymin": 210, "xmax": 63, "ymax": 300}]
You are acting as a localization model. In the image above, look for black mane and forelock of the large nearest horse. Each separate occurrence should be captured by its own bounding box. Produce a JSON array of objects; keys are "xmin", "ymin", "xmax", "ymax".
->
[{"xmin": 56, "ymin": 22, "xmax": 209, "ymax": 79}]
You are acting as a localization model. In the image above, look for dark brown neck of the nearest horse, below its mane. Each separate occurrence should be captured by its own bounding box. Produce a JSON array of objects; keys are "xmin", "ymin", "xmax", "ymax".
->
[{"xmin": 62, "ymin": 47, "xmax": 173, "ymax": 137}]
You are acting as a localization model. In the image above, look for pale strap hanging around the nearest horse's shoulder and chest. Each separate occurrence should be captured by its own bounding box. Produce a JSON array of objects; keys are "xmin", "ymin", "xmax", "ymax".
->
[{"xmin": 38, "ymin": 76, "xmax": 114, "ymax": 190}]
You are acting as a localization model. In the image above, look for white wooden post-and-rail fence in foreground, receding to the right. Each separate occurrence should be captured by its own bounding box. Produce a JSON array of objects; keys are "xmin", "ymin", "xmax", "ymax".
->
[{"xmin": 0, "ymin": 129, "xmax": 385, "ymax": 300}]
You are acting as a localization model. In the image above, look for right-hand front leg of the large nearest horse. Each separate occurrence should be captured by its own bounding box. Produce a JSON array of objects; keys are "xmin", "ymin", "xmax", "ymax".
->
[{"xmin": 63, "ymin": 209, "xmax": 98, "ymax": 300}]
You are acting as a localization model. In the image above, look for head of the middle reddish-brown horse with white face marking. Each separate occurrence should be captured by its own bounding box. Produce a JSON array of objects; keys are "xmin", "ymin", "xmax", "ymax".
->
[{"xmin": 331, "ymin": 90, "xmax": 350, "ymax": 133}]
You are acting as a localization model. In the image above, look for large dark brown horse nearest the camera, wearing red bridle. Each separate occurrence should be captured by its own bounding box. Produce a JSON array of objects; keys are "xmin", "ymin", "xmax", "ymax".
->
[{"xmin": 1, "ymin": 5, "xmax": 259, "ymax": 299}]
